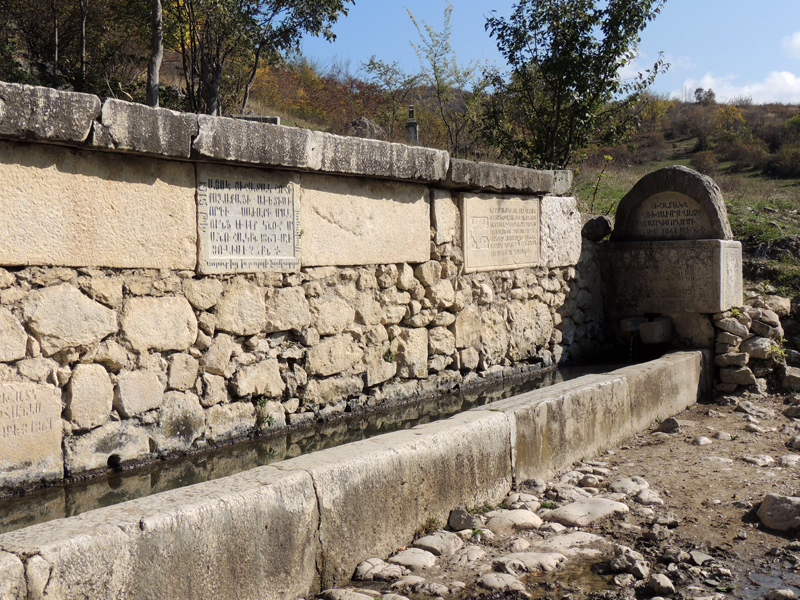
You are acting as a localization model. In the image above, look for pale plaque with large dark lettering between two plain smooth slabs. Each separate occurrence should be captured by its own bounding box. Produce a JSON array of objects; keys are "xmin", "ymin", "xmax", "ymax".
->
[{"xmin": 197, "ymin": 168, "xmax": 300, "ymax": 274}]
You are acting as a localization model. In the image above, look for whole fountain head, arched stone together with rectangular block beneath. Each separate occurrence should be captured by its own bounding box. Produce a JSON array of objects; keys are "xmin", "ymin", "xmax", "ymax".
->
[{"xmin": 604, "ymin": 166, "xmax": 743, "ymax": 342}]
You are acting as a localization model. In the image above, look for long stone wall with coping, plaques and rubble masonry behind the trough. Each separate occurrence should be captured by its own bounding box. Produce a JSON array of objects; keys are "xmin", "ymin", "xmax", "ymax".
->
[{"xmin": 0, "ymin": 84, "xmax": 603, "ymax": 490}]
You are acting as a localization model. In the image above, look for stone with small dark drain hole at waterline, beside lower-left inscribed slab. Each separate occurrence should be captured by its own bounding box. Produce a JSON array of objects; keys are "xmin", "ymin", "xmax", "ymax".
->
[{"xmin": 64, "ymin": 421, "xmax": 150, "ymax": 475}]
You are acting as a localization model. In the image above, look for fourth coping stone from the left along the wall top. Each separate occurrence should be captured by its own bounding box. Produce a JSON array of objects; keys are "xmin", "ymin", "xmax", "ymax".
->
[{"xmin": 312, "ymin": 131, "xmax": 450, "ymax": 182}]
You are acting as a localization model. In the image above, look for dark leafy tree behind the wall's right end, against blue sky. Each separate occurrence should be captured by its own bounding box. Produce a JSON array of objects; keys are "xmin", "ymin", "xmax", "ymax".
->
[{"xmin": 484, "ymin": 0, "xmax": 669, "ymax": 168}]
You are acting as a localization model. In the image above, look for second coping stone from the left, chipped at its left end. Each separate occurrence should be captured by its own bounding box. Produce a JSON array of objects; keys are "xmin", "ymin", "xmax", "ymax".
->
[{"xmin": 91, "ymin": 99, "xmax": 198, "ymax": 158}]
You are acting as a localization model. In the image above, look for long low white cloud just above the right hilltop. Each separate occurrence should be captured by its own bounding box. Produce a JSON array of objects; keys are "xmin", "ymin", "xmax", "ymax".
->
[{"xmin": 672, "ymin": 71, "xmax": 800, "ymax": 104}]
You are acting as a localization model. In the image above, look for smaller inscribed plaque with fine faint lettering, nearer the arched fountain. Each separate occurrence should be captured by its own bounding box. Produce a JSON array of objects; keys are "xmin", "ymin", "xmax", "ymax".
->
[{"xmin": 462, "ymin": 195, "xmax": 541, "ymax": 273}]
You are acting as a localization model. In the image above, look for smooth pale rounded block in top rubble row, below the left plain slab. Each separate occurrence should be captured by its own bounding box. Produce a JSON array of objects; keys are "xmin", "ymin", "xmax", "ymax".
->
[{"xmin": 120, "ymin": 296, "xmax": 197, "ymax": 351}]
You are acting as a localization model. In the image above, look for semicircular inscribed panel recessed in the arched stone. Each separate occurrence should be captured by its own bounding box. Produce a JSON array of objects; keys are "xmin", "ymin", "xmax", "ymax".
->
[{"xmin": 629, "ymin": 192, "xmax": 712, "ymax": 240}]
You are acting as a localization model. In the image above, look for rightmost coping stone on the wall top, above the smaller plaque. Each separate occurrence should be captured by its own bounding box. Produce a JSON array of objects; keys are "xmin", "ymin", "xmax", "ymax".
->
[{"xmin": 447, "ymin": 158, "xmax": 555, "ymax": 194}]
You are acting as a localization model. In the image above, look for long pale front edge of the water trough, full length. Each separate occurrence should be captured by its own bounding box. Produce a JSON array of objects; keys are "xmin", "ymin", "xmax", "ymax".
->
[{"xmin": 0, "ymin": 351, "xmax": 709, "ymax": 600}]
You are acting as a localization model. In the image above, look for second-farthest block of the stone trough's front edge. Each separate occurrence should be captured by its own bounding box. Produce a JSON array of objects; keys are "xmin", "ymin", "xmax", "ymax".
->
[{"xmin": 482, "ymin": 373, "xmax": 632, "ymax": 480}]
